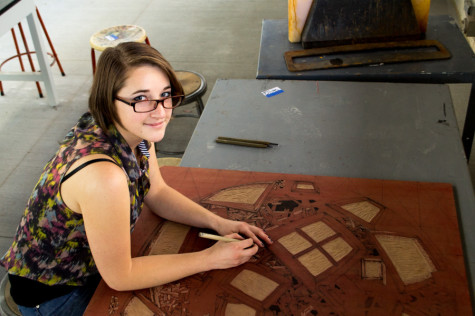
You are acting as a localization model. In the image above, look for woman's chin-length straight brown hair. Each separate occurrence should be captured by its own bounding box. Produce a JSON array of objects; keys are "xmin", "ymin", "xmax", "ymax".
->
[{"xmin": 89, "ymin": 42, "xmax": 184, "ymax": 132}]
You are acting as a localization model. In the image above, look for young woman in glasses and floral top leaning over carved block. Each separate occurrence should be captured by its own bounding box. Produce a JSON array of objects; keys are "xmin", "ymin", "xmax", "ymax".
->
[{"xmin": 1, "ymin": 43, "xmax": 271, "ymax": 316}]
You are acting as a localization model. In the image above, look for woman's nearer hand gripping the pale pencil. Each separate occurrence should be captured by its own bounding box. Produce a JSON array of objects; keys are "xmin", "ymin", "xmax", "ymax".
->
[{"xmin": 206, "ymin": 234, "xmax": 259, "ymax": 270}]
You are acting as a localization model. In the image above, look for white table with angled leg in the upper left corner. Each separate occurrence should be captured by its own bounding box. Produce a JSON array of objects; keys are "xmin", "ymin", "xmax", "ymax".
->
[{"xmin": 0, "ymin": 0, "xmax": 58, "ymax": 106}]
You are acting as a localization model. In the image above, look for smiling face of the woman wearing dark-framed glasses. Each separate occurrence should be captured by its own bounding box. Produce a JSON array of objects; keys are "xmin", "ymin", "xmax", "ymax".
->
[{"xmin": 115, "ymin": 65, "xmax": 172, "ymax": 148}]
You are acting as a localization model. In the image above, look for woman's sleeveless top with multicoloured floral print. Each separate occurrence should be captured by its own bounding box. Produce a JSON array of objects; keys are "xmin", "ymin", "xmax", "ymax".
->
[{"xmin": 0, "ymin": 113, "xmax": 150, "ymax": 285}]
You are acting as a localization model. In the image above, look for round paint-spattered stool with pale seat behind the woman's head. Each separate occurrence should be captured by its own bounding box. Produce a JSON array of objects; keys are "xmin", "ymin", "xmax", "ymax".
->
[{"xmin": 89, "ymin": 25, "xmax": 150, "ymax": 74}]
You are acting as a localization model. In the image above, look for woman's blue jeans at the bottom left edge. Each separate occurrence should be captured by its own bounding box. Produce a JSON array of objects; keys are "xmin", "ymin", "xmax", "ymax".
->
[{"xmin": 18, "ymin": 286, "xmax": 96, "ymax": 316}]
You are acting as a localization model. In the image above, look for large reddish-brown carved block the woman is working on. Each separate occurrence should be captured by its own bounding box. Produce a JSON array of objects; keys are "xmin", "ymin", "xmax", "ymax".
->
[{"xmin": 85, "ymin": 167, "xmax": 473, "ymax": 316}]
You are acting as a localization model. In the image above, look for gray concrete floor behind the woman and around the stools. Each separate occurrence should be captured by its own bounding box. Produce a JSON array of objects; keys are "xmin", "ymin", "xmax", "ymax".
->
[{"xmin": 0, "ymin": 0, "xmax": 475, "ymax": 286}]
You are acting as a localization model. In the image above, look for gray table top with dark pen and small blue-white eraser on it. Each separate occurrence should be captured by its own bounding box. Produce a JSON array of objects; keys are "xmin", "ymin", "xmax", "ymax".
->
[{"xmin": 181, "ymin": 79, "xmax": 475, "ymax": 296}]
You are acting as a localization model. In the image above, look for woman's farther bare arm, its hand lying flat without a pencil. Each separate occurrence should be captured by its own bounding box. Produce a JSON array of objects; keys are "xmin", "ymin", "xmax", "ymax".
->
[{"xmin": 145, "ymin": 144, "xmax": 272, "ymax": 247}]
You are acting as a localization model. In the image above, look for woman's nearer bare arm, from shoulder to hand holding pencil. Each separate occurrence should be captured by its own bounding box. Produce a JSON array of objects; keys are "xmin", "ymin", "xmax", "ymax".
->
[{"xmin": 62, "ymin": 158, "xmax": 257, "ymax": 291}]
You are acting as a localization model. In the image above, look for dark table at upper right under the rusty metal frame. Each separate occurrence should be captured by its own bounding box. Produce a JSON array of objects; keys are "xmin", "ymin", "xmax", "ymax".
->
[{"xmin": 257, "ymin": 16, "xmax": 475, "ymax": 159}]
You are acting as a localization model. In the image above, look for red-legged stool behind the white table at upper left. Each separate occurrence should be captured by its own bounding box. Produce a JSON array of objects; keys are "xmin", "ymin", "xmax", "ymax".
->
[{"xmin": 0, "ymin": 8, "xmax": 66, "ymax": 98}]
